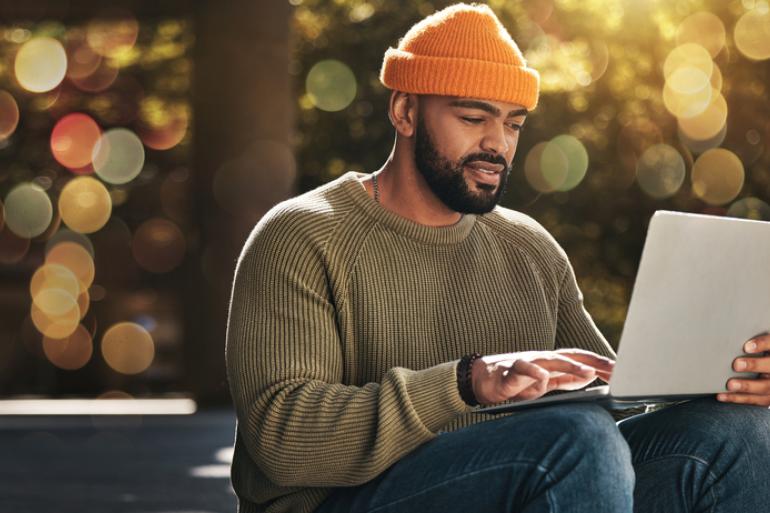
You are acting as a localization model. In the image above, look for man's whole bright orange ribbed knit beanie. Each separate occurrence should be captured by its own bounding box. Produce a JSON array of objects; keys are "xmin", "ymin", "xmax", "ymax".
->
[{"xmin": 380, "ymin": 4, "xmax": 540, "ymax": 110}]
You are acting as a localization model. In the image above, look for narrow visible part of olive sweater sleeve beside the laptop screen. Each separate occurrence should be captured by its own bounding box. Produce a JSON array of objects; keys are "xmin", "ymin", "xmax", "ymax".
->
[{"xmin": 556, "ymin": 254, "xmax": 616, "ymax": 360}]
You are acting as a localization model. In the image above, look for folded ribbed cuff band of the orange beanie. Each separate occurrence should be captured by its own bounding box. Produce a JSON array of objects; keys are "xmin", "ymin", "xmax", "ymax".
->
[{"xmin": 380, "ymin": 48, "xmax": 540, "ymax": 111}]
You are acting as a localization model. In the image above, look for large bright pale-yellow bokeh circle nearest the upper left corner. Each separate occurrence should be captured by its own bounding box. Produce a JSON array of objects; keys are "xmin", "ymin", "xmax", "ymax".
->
[{"xmin": 14, "ymin": 37, "xmax": 67, "ymax": 93}]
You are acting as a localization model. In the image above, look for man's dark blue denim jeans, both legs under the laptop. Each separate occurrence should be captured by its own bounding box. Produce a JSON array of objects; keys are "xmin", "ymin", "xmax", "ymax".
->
[{"xmin": 317, "ymin": 398, "xmax": 770, "ymax": 513}]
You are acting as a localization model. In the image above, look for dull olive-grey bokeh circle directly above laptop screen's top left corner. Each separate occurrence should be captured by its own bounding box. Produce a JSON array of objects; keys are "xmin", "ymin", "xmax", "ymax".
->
[{"xmin": 636, "ymin": 144, "xmax": 685, "ymax": 199}]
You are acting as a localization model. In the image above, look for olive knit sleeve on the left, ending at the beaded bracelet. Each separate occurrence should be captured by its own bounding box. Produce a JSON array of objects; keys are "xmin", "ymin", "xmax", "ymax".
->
[{"xmin": 226, "ymin": 209, "xmax": 470, "ymax": 487}]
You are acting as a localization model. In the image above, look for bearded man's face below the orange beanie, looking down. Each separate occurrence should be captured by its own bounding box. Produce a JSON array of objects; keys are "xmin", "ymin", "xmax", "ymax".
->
[{"xmin": 414, "ymin": 96, "xmax": 526, "ymax": 214}]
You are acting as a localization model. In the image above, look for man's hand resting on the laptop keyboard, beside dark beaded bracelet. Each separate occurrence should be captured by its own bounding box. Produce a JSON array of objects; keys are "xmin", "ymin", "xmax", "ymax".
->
[{"xmin": 471, "ymin": 349, "xmax": 615, "ymax": 405}]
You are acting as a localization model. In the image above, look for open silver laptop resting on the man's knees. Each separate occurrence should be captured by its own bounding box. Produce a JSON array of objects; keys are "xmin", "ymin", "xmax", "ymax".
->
[{"xmin": 475, "ymin": 210, "xmax": 770, "ymax": 413}]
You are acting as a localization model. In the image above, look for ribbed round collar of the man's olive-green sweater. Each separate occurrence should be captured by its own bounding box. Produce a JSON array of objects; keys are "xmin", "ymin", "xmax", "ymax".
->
[{"xmin": 339, "ymin": 171, "xmax": 476, "ymax": 244}]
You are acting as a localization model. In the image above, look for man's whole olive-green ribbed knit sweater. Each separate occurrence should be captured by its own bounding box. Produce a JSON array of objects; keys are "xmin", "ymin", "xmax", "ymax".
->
[{"xmin": 226, "ymin": 172, "xmax": 615, "ymax": 513}]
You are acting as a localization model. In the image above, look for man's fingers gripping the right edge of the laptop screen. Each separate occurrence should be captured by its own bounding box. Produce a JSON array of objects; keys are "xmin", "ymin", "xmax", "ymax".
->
[{"xmin": 717, "ymin": 335, "xmax": 770, "ymax": 406}]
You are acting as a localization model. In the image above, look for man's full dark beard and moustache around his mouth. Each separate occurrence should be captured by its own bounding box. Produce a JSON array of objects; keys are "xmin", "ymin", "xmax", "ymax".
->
[{"xmin": 414, "ymin": 116, "xmax": 512, "ymax": 214}]
